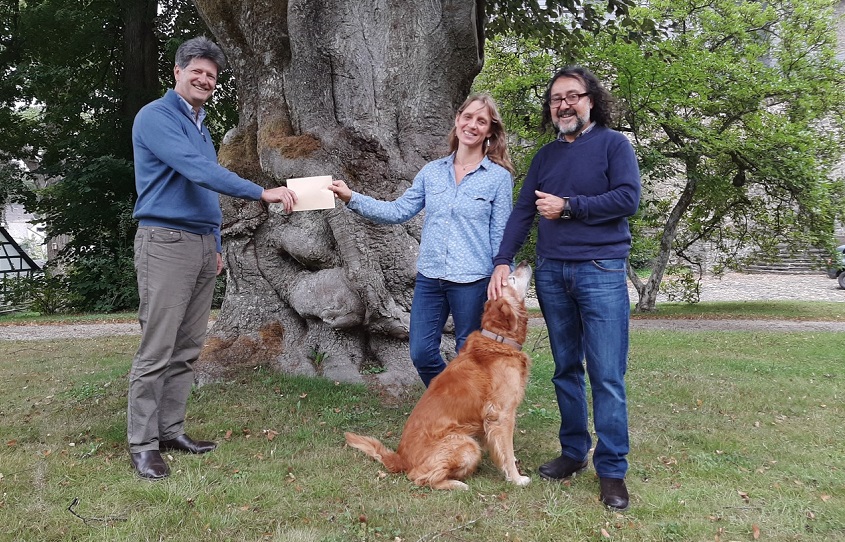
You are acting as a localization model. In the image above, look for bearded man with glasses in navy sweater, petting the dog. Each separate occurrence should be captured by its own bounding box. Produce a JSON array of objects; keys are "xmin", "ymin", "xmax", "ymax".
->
[{"xmin": 488, "ymin": 67, "xmax": 640, "ymax": 510}]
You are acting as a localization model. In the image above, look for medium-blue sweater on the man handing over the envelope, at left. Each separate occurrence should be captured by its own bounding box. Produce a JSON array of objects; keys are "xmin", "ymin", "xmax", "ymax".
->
[{"xmin": 132, "ymin": 89, "xmax": 264, "ymax": 252}]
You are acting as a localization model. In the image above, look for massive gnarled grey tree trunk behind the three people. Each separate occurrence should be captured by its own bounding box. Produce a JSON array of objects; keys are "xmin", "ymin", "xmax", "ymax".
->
[{"xmin": 190, "ymin": 0, "xmax": 483, "ymax": 389}]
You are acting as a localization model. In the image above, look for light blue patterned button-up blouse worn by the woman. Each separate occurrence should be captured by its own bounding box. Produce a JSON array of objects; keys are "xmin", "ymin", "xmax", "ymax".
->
[{"xmin": 347, "ymin": 154, "xmax": 513, "ymax": 283}]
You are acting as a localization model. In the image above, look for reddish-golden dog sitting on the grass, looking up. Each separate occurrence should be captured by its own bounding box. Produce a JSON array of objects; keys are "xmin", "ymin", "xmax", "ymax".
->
[{"xmin": 344, "ymin": 262, "xmax": 531, "ymax": 489}]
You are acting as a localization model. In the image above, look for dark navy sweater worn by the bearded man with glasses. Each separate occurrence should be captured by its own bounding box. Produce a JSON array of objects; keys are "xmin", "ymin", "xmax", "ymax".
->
[{"xmin": 493, "ymin": 126, "xmax": 640, "ymax": 265}]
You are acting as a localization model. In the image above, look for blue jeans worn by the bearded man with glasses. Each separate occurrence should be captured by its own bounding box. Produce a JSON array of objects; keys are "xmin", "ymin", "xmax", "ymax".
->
[{"xmin": 534, "ymin": 258, "xmax": 631, "ymax": 478}]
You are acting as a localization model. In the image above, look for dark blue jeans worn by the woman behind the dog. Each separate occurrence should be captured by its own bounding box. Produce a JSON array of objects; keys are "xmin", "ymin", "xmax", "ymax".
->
[{"xmin": 409, "ymin": 273, "xmax": 489, "ymax": 387}]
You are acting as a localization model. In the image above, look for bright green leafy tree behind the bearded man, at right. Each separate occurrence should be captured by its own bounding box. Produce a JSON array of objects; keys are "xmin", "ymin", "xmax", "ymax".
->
[{"xmin": 477, "ymin": 0, "xmax": 845, "ymax": 310}]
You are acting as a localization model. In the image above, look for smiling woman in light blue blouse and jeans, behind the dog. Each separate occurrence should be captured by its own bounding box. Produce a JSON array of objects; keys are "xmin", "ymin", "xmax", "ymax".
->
[{"xmin": 330, "ymin": 94, "xmax": 514, "ymax": 392}]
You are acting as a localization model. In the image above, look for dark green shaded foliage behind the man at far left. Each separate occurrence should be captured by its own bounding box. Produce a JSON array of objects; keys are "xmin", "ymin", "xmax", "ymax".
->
[{"xmin": 0, "ymin": 0, "xmax": 221, "ymax": 310}]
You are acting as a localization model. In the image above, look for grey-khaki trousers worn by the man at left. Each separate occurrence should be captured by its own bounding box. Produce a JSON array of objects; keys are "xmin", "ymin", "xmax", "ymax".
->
[{"xmin": 126, "ymin": 227, "xmax": 217, "ymax": 453}]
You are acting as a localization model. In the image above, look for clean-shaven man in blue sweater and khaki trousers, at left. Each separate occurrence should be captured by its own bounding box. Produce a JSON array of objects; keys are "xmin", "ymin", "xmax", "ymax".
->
[{"xmin": 127, "ymin": 37, "xmax": 296, "ymax": 480}]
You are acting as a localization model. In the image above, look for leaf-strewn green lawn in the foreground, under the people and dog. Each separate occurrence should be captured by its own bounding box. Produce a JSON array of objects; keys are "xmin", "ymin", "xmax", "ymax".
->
[{"xmin": 0, "ymin": 308, "xmax": 845, "ymax": 542}]
